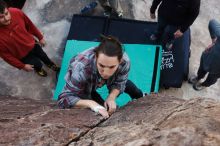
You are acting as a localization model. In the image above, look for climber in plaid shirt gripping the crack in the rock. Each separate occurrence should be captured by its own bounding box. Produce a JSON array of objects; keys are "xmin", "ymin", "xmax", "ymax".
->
[{"xmin": 58, "ymin": 36, "xmax": 143, "ymax": 118}]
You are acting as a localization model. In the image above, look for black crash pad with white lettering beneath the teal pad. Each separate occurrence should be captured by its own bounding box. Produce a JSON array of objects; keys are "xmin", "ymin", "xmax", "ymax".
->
[{"xmin": 67, "ymin": 15, "xmax": 190, "ymax": 88}]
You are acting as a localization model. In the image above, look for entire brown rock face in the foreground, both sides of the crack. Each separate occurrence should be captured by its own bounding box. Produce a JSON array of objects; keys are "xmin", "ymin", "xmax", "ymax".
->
[{"xmin": 0, "ymin": 95, "xmax": 220, "ymax": 146}]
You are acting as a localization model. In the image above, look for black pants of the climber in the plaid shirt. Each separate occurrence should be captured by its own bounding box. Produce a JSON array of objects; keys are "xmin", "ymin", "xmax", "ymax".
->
[{"xmin": 91, "ymin": 80, "xmax": 143, "ymax": 105}]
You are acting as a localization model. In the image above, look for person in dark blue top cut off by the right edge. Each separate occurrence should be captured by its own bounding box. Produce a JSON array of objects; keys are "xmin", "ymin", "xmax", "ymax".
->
[{"xmin": 188, "ymin": 19, "xmax": 220, "ymax": 91}]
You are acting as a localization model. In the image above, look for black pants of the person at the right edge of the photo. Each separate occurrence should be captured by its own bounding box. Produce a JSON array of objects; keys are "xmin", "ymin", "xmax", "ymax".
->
[{"xmin": 197, "ymin": 57, "xmax": 220, "ymax": 87}]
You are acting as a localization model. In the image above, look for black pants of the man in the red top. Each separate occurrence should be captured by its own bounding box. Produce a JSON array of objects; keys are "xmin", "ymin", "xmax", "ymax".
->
[{"xmin": 21, "ymin": 44, "xmax": 54, "ymax": 71}]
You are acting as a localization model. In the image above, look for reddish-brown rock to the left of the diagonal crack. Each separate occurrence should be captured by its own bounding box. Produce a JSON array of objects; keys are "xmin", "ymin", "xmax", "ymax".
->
[{"xmin": 0, "ymin": 97, "xmax": 102, "ymax": 146}]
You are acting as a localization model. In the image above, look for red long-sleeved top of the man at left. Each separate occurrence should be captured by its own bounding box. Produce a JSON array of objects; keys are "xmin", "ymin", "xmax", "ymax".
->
[{"xmin": 0, "ymin": 8, "xmax": 43, "ymax": 69}]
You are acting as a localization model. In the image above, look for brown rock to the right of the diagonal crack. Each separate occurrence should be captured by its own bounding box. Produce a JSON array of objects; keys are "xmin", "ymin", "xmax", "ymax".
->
[{"xmin": 71, "ymin": 96, "xmax": 220, "ymax": 146}]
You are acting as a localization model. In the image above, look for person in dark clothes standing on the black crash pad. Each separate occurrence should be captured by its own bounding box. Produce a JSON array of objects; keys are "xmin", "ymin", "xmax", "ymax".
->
[{"xmin": 150, "ymin": 0, "xmax": 200, "ymax": 49}]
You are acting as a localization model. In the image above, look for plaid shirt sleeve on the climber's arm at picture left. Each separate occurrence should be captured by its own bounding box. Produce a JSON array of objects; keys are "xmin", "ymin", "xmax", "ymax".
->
[{"xmin": 58, "ymin": 63, "xmax": 86, "ymax": 108}]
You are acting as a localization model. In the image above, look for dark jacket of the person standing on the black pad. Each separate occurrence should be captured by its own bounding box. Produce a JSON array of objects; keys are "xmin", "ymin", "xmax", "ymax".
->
[{"xmin": 150, "ymin": 0, "xmax": 200, "ymax": 32}]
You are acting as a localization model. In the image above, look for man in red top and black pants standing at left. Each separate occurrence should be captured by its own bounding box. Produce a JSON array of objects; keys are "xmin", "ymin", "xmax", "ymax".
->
[{"xmin": 0, "ymin": 0, "xmax": 59, "ymax": 77}]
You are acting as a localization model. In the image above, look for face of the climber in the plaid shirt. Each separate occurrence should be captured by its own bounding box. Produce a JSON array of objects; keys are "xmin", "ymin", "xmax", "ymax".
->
[{"xmin": 96, "ymin": 53, "xmax": 120, "ymax": 79}]
